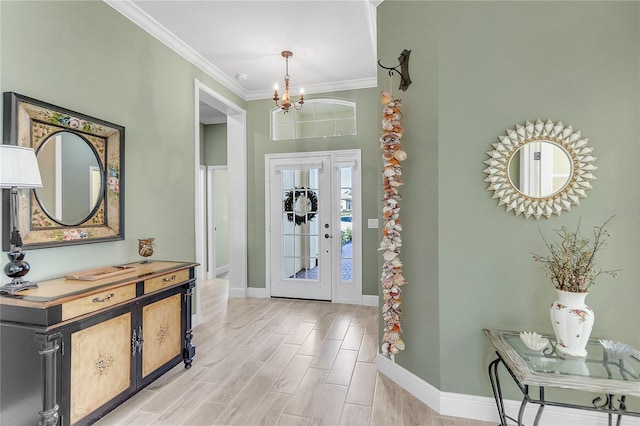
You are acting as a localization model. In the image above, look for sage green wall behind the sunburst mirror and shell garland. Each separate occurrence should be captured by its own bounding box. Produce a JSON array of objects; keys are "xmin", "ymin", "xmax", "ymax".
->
[{"xmin": 378, "ymin": 0, "xmax": 640, "ymax": 396}]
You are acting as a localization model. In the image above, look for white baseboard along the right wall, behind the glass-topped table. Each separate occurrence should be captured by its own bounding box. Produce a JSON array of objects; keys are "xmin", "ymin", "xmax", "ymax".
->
[{"xmin": 376, "ymin": 354, "xmax": 640, "ymax": 426}]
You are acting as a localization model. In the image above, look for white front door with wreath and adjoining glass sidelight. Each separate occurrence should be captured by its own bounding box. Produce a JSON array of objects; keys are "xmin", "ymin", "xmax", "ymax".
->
[{"xmin": 266, "ymin": 151, "xmax": 362, "ymax": 303}]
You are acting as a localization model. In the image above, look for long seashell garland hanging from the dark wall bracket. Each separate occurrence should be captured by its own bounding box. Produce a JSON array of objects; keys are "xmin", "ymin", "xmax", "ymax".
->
[{"xmin": 378, "ymin": 91, "xmax": 407, "ymax": 360}]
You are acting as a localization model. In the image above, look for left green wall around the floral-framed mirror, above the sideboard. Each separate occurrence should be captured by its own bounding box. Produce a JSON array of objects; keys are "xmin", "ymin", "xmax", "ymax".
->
[{"xmin": 0, "ymin": 1, "xmax": 244, "ymax": 280}]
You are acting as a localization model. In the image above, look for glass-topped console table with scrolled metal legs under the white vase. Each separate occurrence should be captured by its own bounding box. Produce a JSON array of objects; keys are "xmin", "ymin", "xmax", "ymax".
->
[{"xmin": 483, "ymin": 329, "xmax": 640, "ymax": 426}]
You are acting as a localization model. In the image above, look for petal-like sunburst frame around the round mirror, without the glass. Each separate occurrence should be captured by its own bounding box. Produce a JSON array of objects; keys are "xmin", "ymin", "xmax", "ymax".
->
[{"xmin": 483, "ymin": 120, "xmax": 597, "ymax": 219}]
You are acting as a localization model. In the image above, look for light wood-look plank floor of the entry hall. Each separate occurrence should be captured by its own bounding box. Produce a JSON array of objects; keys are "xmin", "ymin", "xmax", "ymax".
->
[{"xmin": 96, "ymin": 279, "xmax": 496, "ymax": 426}]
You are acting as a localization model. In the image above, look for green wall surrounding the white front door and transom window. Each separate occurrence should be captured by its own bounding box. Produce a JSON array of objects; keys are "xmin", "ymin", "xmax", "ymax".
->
[{"xmin": 247, "ymin": 89, "xmax": 382, "ymax": 295}]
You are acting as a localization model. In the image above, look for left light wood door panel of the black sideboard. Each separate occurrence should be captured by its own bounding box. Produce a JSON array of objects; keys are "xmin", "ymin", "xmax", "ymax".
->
[{"xmin": 70, "ymin": 312, "xmax": 132, "ymax": 424}]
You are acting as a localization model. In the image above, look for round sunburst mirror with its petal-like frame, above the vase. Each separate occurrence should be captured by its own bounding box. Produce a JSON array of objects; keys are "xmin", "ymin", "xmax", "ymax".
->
[{"xmin": 484, "ymin": 120, "xmax": 597, "ymax": 219}]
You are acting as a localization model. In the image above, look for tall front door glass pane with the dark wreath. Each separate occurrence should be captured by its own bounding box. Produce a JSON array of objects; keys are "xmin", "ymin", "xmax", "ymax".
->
[{"xmin": 281, "ymin": 169, "xmax": 320, "ymax": 280}]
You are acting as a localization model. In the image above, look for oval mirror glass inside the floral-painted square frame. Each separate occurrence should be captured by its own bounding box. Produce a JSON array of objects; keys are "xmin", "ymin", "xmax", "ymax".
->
[{"xmin": 36, "ymin": 132, "xmax": 104, "ymax": 225}]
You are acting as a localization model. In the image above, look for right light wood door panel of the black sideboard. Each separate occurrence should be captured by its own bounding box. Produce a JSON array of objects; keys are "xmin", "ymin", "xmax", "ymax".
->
[{"xmin": 142, "ymin": 293, "xmax": 182, "ymax": 378}]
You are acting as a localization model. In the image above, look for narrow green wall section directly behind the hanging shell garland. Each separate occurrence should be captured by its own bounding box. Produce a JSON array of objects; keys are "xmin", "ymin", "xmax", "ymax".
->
[{"xmin": 378, "ymin": 1, "xmax": 442, "ymax": 387}]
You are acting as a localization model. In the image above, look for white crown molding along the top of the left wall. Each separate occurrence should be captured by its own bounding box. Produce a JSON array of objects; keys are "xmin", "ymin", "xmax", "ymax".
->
[{"xmin": 103, "ymin": 0, "xmax": 248, "ymax": 100}]
